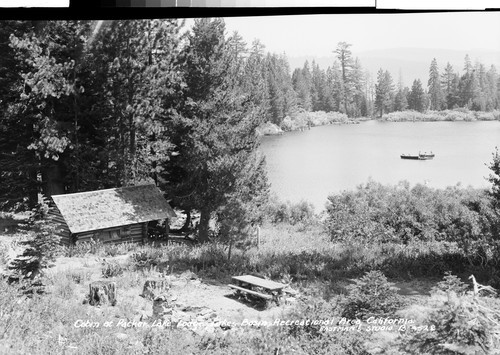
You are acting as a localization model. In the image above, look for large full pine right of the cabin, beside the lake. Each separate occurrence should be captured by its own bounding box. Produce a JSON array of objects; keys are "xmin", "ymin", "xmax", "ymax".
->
[{"xmin": 165, "ymin": 19, "xmax": 267, "ymax": 242}]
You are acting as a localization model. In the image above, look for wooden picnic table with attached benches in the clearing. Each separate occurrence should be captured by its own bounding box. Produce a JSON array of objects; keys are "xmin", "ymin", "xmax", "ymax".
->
[{"xmin": 229, "ymin": 275, "xmax": 287, "ymax": 304}]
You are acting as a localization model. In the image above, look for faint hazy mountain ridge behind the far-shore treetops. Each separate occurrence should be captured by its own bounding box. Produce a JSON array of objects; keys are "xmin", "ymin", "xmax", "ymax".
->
[{"xmin": 288, "ymin": 48, "xmax": 500, "ymax": 87}]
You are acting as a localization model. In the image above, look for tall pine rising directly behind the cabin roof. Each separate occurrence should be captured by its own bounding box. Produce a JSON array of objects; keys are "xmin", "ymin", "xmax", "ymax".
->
[{"xmin": 81, "ymin": 20, "xmax": 182, "ymax": 188}]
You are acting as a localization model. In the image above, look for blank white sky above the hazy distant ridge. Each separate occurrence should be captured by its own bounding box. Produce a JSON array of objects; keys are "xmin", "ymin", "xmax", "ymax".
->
[{"xmin": 221, "ymin": 12, "xmax": 500, "ymax": 57}]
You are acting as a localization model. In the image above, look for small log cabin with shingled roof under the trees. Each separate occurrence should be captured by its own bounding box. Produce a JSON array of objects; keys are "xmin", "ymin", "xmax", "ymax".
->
[{"xmin": 50, "ymin": 185, "xmax": 176, "ymax": 245}]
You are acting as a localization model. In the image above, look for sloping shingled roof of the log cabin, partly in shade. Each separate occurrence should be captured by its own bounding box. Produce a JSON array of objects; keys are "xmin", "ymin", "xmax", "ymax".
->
[{"xmin": 52, "ymin": 185, "xmax": 176, "ymax": 233}]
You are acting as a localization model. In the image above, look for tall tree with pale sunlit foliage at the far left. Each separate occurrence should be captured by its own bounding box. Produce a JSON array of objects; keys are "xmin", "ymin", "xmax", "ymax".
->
[{"xmin": 1, "ymin": 21, "xmax": 89, "ymax": 205}]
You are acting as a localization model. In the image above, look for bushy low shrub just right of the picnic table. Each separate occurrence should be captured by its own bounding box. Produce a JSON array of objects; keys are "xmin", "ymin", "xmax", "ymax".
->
[{"xmin": 342, "ymin": 271, "xmax": 403, "ymax": 319}]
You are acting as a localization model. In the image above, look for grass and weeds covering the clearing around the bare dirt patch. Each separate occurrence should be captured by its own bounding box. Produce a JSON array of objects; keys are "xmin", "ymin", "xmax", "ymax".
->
[{"xmin": 0, "ymin": 216, "xmax": 500, "ymax": 354}]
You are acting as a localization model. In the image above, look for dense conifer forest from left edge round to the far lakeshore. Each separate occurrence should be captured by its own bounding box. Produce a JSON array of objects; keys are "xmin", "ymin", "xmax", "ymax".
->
[{"xmin": 0, "ymin": 19, "xmax": 500, "ymax": 221}]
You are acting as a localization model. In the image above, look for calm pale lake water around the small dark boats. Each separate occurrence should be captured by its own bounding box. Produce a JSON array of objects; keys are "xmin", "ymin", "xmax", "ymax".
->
[{"xmin": 261, "ymin": 121, "xmax": 500, "ymax": 211}]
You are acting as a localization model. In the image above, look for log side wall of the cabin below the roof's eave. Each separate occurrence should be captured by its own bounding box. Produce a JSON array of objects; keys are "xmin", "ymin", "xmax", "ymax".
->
[{"xmin": 75, "ymin": 223, "xmax": 145, "ymax": 243}]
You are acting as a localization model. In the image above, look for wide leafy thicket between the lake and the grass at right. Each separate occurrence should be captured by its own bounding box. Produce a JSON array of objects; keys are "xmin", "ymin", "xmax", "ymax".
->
[{"xmin": 326, "ymin": 181, "xmax": 495, "ymax": 250}]
